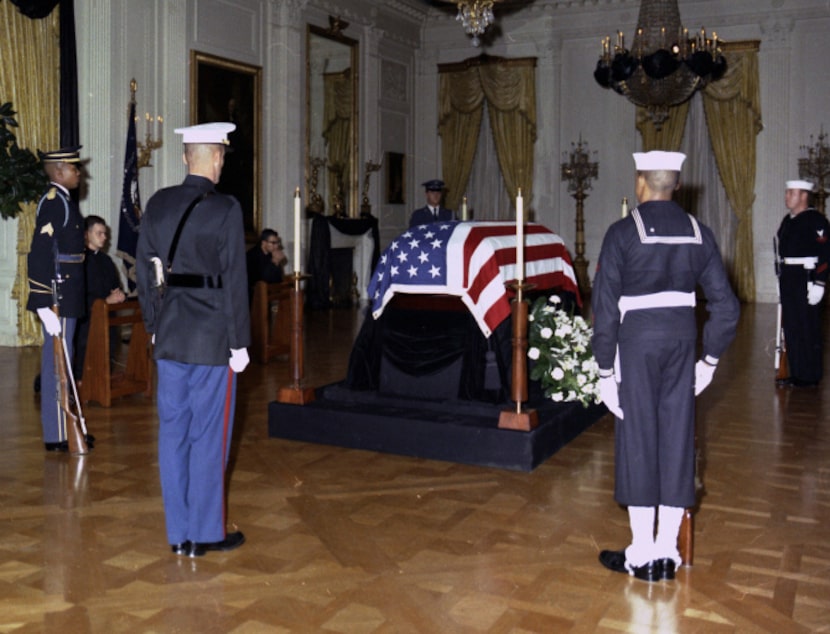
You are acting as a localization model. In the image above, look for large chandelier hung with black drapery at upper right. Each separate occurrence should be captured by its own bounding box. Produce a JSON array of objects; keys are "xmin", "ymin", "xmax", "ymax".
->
[{"xmin": 594, "ymin": 0, "xmax": 726, "ymax": 130}]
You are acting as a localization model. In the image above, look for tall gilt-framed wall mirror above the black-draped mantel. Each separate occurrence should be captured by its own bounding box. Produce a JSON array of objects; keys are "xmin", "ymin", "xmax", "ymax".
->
[{"xmin": 306, "ymin": 18, "xmax": 359, "ymax": 217}]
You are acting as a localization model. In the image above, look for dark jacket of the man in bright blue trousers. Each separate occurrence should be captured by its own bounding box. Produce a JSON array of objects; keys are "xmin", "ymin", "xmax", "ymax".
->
[{"xmin": 136, "ymin": 175, "xmax": 251, "ymax": 365}]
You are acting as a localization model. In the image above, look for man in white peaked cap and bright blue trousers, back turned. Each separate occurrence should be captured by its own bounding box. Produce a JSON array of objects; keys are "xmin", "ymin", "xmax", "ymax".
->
[{"xmin": 136, "ymin": 123, "xmax": 251, "ymax": 557}]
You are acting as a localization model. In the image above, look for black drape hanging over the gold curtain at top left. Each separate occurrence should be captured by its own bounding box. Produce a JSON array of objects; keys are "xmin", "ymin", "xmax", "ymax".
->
[{"xmin": 11, "ymin": 0, "xmax": 80, "ymax": 147}]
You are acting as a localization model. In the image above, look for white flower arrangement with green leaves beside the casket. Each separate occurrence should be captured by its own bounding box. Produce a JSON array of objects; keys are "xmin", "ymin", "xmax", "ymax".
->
[{"xmin": 527, "ymin": 295, "xmax": 601, "ymax": 407}]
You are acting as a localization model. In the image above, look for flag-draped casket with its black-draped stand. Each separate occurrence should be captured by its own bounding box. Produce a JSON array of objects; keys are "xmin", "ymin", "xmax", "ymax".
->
[{"xmin": 346, "ymin": 222, "xmax": 579, "ymax": 402}]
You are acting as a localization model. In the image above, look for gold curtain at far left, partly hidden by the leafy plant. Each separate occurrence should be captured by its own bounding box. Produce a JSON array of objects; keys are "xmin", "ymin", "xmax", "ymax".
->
[{"xmin": 0, "ymin": 2, "xmax": 60, "ymax": 346}]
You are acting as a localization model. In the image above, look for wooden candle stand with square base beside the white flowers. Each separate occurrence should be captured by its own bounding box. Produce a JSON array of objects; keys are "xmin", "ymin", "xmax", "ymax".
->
[{"xmin": 499, "ymin": 280, "xmax": 539, "ymax": 431}]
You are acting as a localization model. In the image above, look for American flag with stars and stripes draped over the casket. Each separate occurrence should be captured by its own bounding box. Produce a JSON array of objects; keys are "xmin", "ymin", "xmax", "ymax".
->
[{"xmin": 369, "ymin": 222, "xmax": 579, "ymax": 337}]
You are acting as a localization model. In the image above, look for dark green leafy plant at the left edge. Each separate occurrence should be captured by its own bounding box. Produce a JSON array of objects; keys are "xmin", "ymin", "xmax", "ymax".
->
[{"xmin": 0, "ymin": 101, "xmax": 49, "ymax": 219}]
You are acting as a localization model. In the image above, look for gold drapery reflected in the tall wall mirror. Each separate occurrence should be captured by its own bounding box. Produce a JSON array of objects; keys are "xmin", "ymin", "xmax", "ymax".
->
[{"xmin": 323, "ymin": 68, "xmax": 354, "ymax": 213}]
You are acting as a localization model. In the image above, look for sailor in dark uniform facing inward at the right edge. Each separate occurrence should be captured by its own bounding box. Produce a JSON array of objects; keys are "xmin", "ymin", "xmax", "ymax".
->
[{"xmin": 776, "ymin": 180, "xmax": 830, "ymax": 387}]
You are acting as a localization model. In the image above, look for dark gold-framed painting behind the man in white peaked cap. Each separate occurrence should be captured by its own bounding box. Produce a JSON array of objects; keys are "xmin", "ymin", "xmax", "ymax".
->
[{"xmin": 190, "ymin": 51, "xmax": 262, "ymax": 237}]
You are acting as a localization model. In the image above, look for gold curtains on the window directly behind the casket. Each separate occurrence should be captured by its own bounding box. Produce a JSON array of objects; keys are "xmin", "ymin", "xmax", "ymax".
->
[{"xmin": 438, "ymin": 56, "xmax": 536, "ymax": 214}]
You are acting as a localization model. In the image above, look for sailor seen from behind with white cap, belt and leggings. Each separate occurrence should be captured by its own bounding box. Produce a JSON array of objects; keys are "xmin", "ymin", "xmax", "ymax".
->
[{"xmin": 591, "ymin": 152, "xmax": 740, "ymax": 581}]
